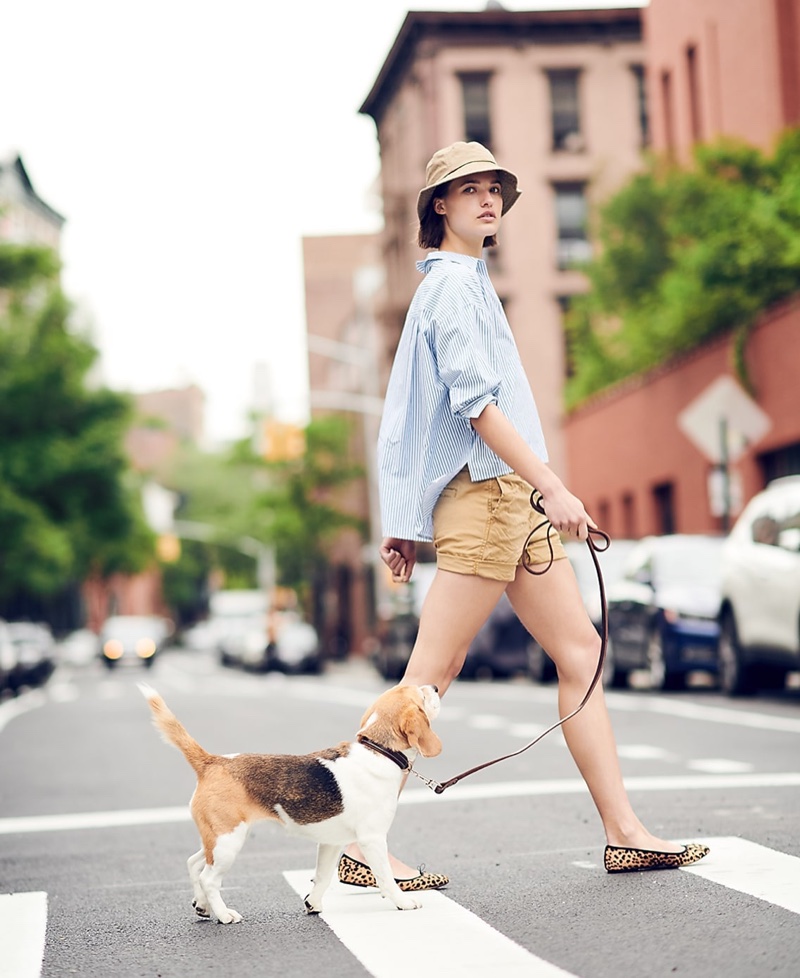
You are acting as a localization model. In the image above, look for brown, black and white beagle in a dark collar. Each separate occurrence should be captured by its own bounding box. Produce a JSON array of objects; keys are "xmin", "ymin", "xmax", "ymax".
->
[{"xmin": 139, "ymin": 683, "xmax": 442, "ymax": 924}]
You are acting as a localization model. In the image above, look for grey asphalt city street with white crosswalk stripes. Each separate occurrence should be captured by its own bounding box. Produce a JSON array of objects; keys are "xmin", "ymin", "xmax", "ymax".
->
[{"xmin": 0, "ymin": 650, "xmax": 800, "ymax": 978}]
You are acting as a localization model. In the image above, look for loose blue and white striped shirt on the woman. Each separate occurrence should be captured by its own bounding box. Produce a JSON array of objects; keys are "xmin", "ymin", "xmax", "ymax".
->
[{"xmin": 378, "ymin": 251, "xmax": 547, "ymax": 540}]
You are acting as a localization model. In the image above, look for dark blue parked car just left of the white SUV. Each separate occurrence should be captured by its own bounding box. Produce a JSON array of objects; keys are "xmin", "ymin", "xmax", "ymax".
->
[{"xmin": 606, "ymin": 534, "xmax": 724, "ymax": 689}]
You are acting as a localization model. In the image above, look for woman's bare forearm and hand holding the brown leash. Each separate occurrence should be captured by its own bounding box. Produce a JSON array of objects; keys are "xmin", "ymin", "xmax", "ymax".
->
[{"xmin": 472, "ymin": 404, "xmax": 596, "ymax": 540}]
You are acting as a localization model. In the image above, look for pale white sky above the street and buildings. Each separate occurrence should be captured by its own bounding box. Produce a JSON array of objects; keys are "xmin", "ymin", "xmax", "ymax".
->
[{"xmin": 0, "ymin": 0, "xmax": 642, "ymax": 446}]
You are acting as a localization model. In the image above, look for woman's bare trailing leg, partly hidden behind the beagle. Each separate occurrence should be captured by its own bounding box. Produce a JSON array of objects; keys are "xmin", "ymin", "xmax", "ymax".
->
[{"xmin": 345, "ymin": 570, "xmax": 506, "ymax": 879}]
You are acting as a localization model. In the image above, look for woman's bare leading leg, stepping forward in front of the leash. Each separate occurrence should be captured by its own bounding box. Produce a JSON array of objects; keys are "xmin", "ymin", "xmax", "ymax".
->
[{"xmin": 506, "ymin": 559, "xmax": 683, "ymax": 852}]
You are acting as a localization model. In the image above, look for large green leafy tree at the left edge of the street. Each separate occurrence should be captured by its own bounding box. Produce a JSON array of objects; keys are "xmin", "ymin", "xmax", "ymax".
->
[{"xmin": 0, "ymin": 244, "xmax": 152, "ymax": 601}]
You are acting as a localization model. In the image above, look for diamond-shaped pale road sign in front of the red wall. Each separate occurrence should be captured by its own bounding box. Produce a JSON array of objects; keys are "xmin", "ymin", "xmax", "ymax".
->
[{"xmin": 678, "ymin": 376, "xmax": 772, "ymax": 465}]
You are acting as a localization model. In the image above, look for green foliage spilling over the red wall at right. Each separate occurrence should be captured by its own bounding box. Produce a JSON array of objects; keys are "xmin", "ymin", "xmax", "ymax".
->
[{"xmin": 566, "ymin": 130, "xmax": 800, "ymax": 406}]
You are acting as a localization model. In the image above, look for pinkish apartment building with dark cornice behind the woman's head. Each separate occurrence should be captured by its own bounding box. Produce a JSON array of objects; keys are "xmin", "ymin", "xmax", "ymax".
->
[{"xmin": 361, "ymin": 6, "xmax": 649, "ymax": 477}]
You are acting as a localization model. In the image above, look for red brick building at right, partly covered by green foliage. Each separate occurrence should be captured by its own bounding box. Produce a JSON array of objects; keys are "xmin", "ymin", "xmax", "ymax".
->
[{"xmin": 564, "ymin": 0, "xmax": 800, "ymax": 537}]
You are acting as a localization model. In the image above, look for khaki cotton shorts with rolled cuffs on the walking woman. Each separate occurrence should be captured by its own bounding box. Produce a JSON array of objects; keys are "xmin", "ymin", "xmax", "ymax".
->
[{"xmin": 433, "ymin": 469, "xmax": 567, "ymax": 581}]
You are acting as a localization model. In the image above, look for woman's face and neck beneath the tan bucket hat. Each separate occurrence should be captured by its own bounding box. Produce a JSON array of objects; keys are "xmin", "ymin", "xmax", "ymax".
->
[{"xmin": 434, "ymin": 170, "xmax": 503, "ymax": 256}]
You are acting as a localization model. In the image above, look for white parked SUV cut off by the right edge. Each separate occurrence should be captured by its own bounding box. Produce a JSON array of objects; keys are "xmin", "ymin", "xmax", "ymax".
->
[{"xmin": 719, "ymin": 476, "xmax": 800, "ymax": 696}]
